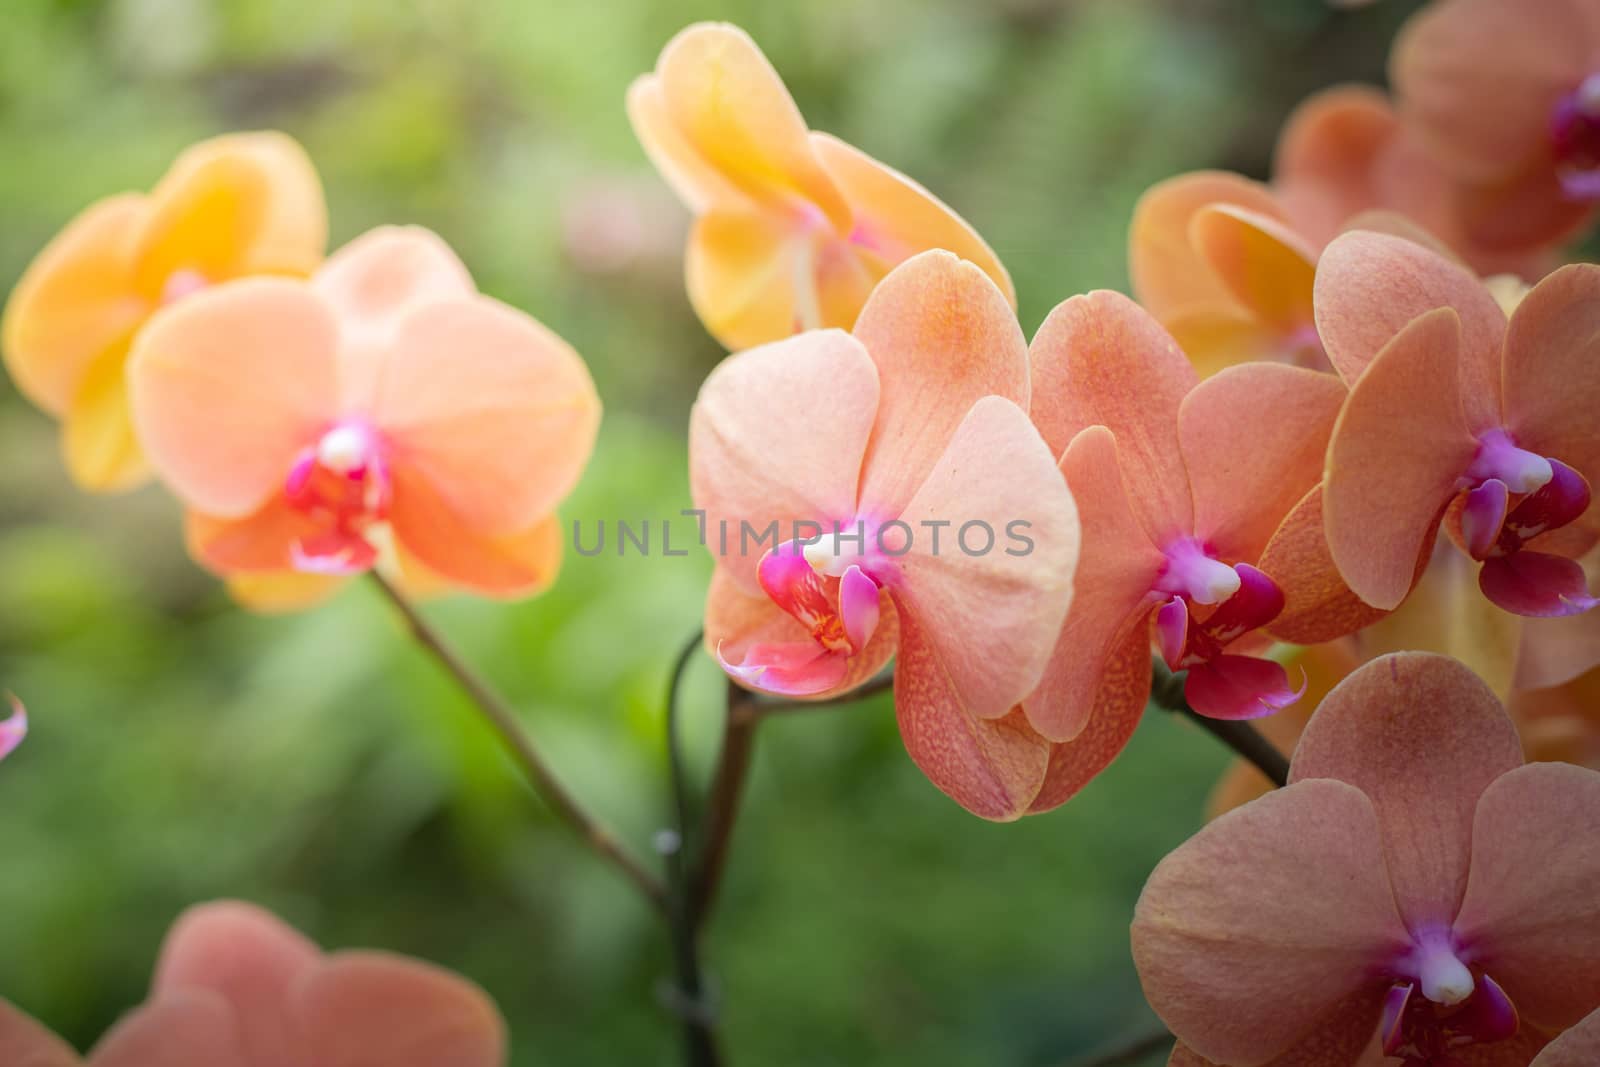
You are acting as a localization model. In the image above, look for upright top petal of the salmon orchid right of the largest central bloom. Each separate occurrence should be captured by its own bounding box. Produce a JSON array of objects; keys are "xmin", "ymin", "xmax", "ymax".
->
[{"xmin": 1029, "ymin": 291, "xmax": 1198, "ymax": 544}]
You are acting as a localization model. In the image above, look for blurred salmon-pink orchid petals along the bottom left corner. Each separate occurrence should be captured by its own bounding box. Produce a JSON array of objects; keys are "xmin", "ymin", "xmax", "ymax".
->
[{"xmin": 0, "ymin": 902, "xmax": 506, "ymax": 1067}]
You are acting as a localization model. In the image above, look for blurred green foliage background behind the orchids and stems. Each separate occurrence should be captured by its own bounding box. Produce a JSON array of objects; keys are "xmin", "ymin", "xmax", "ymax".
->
[{"xmin": 0, "ymin": 0, "xmax": 1416, "ymax": 1067}]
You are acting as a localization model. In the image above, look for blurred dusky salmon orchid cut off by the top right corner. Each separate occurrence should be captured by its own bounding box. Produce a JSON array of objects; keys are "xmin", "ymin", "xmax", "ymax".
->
[{"xmin": 1390, "ymin": 0, "xmax": 1600, "ymax": 254}]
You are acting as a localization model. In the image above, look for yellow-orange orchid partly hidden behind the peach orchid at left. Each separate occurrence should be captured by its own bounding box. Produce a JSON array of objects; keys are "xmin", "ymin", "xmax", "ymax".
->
[{"xmin": 3, "ymin": 133, "xmax": 328, "ymax": 491}]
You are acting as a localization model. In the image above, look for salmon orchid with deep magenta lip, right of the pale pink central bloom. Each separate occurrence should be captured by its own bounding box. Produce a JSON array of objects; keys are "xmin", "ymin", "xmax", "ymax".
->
[{"xmin": 1022, "ymin": 293, "xmax": 1370, "ymax": 787}]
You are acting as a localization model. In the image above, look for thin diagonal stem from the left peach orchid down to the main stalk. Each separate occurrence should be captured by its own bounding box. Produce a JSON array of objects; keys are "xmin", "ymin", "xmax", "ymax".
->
[{"xmin": 371, "ymin": 571, "xmax": 667, "ymax": 910}]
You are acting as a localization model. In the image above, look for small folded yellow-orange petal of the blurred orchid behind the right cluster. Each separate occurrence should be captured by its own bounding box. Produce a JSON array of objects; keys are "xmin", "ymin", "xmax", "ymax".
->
[{"xmin": 1189, "ymin": 205, "xmax": 1317, "ymax": 333}]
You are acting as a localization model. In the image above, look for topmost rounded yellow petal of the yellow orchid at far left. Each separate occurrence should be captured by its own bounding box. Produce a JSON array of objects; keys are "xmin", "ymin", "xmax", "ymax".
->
[{"xmin": 133, "ymin": 131, "xmax": 328, "ymax": 301}]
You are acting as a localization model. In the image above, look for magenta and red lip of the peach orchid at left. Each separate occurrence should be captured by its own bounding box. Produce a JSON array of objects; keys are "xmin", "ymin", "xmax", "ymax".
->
[{"xmin": 283, "ymin": 421, "xmax": 390, "ymax": 574}]
